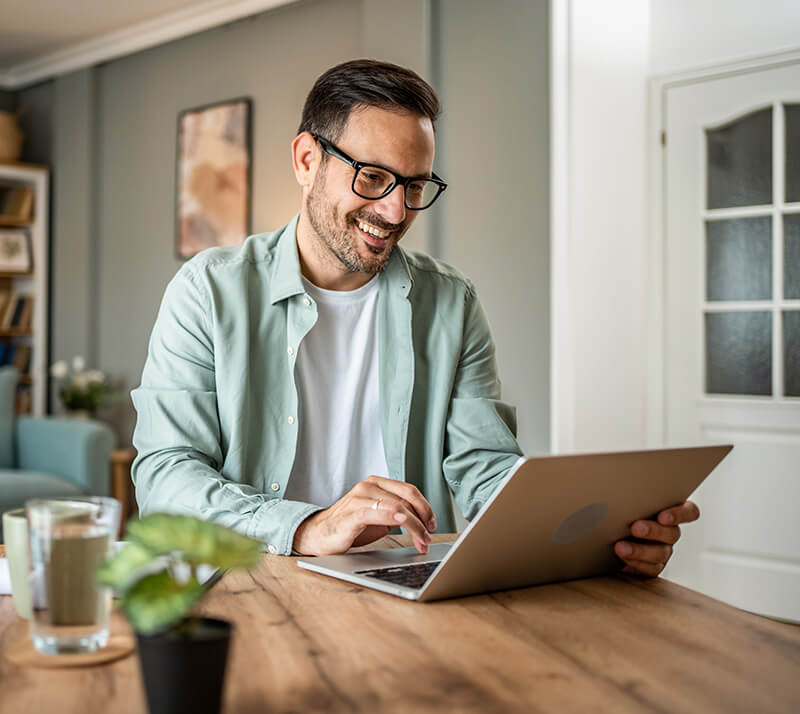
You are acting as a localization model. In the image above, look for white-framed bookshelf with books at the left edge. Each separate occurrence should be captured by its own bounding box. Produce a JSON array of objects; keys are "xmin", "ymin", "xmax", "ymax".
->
[{"xmin": 0, "ymin": 163, "xmax": 50, "ymax": 416}]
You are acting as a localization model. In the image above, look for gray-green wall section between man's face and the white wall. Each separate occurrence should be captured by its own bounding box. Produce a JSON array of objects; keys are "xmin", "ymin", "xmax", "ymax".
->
[{"xmin": 434, "ymin": 0, "xmax": 550, "ymax": 453}]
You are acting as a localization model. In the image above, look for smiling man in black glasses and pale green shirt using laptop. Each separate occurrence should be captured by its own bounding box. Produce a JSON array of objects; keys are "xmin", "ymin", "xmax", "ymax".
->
[{"xmin": 132, "ymin": 60, "xmax": 698, "ymax": 575}]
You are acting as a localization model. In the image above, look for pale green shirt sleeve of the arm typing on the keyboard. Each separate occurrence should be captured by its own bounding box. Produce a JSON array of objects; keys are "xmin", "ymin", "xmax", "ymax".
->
[{"xmin": 131, "ymin": 263, "xmax": 319, "ymax": 555}]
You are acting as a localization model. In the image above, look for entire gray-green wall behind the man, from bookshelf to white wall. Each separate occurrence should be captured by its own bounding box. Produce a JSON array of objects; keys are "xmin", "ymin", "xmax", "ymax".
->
[{"xmin": 18, "ymin": 0, "xmax": 550, "ymax": 451}]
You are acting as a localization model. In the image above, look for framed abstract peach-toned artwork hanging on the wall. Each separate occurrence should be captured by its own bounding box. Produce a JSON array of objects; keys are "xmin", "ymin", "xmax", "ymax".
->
[{"xmin": 175, "ymin": 98, "xmax": 252, "ymax": 260}]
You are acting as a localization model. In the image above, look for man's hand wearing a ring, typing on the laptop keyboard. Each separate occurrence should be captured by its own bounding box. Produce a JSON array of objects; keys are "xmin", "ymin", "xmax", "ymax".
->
[{"xmin": 292, "ymin": 476, "xmax": 436, "ymax": 555}]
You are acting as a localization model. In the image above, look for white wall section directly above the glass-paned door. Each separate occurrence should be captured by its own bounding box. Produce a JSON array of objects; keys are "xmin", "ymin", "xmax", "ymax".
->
[{"xmin": 650, "ymin": 0, "xmax": 800, "ymax": 74}]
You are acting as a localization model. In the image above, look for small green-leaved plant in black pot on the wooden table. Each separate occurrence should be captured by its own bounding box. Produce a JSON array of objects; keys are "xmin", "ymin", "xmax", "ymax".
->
[{"xmin": 98, "ymin": 513, "xmax": 263, "ymax": 714}]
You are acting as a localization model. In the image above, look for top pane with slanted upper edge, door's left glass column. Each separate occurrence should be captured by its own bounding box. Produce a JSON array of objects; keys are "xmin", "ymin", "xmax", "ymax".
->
[{"xmin": 706, "ymin": 107, "xmax": 772, "ymax": 208}]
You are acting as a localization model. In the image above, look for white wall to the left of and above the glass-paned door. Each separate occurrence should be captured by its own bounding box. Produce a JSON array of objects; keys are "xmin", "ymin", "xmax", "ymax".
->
[{"xmin": 551, "ymin": 0, "xmax": 800, "ymax": 452}]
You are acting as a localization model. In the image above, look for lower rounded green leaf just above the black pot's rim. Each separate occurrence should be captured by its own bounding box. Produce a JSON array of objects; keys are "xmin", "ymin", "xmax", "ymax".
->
[{"xmin": 122, "ymin": 570, "xmax": 205, "ymax": 634}]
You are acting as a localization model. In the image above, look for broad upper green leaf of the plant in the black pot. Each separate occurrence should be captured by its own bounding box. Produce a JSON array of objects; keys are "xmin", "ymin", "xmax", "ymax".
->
[{"xmin": 127, "ymin": 513, "xmax": 264, "ymax": 570}]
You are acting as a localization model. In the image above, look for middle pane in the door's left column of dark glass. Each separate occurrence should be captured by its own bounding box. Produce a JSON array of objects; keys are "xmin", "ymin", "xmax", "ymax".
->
[{"xmin": 706, "ymin": 216, "xmax": 772, "ymax": 300}]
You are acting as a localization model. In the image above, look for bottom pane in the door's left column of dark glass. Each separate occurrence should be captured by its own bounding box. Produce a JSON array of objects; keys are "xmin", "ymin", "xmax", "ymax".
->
[{"xmin": 706, "ymin": 311, "xmax": 772, "ymax": 394}]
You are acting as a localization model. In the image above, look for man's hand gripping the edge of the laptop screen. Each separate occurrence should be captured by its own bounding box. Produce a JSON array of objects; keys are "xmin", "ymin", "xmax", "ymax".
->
[{"xmin": 614, "ymin": 501, "xmax": 700, "ymax": 577}]
